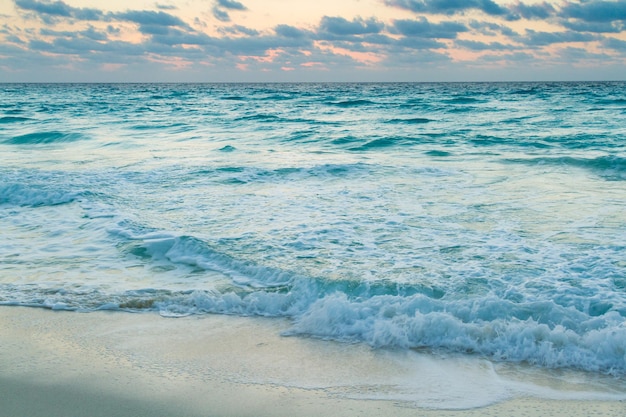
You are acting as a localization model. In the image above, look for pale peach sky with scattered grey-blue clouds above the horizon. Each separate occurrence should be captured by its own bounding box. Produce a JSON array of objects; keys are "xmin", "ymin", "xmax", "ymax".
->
[{"xmin": 0, "ymin": 0, "xmax": 626, "ymax": 82}]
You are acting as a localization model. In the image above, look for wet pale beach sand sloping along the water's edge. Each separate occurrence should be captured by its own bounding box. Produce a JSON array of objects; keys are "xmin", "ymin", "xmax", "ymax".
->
[{"xmin": 0, "ymin": 307, "xmax": 626, "ymax": 417}]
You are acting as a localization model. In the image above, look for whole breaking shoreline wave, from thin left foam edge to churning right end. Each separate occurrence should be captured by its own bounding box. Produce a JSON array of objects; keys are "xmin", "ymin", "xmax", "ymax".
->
[{"xmin": 0, "ymin": 256, "xmax": 626, "ymax": 375}]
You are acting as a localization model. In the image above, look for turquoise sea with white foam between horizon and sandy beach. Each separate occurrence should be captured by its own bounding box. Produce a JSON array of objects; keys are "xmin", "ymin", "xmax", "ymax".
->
[{"xmin": 0, "ymin": 82, "xmax": 626, "ymax": 406}]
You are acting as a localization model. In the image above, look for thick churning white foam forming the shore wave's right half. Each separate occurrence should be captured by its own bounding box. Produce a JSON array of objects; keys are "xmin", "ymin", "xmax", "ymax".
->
[{"xmin": 290, "ymin": 294, "xmax": 626, "ymax": 374}]
